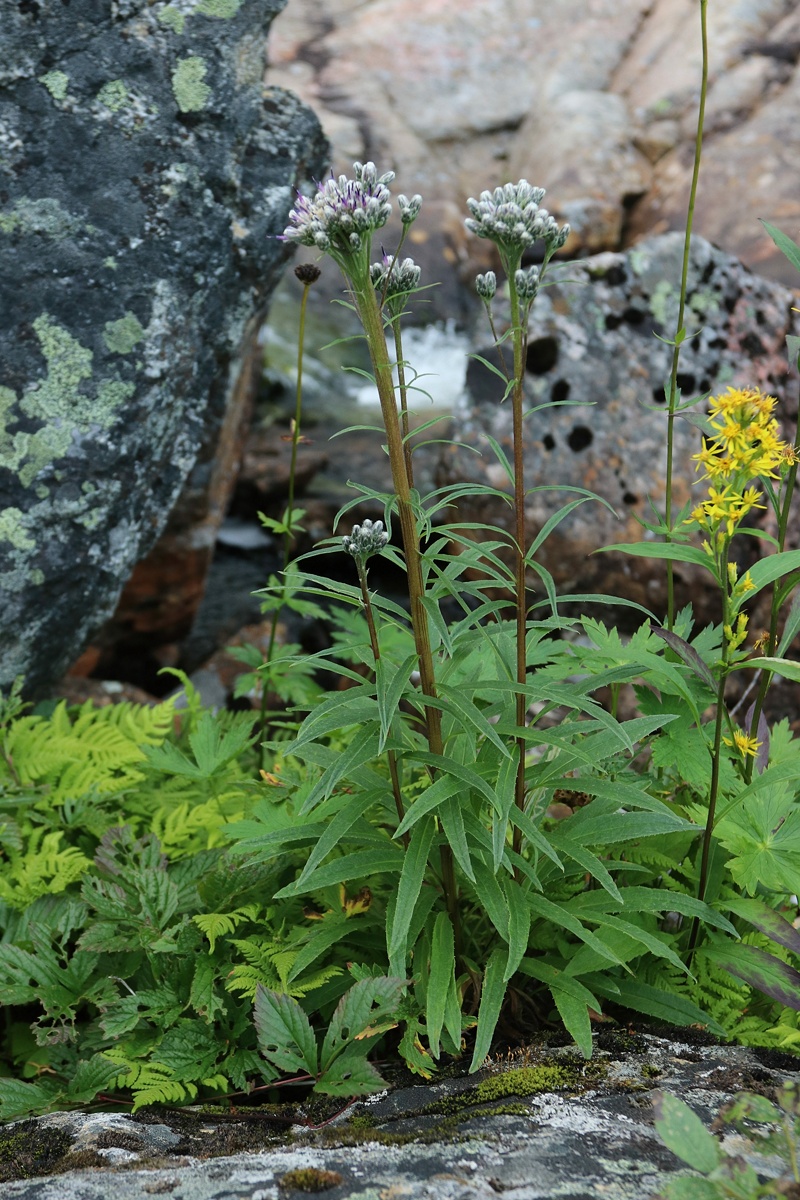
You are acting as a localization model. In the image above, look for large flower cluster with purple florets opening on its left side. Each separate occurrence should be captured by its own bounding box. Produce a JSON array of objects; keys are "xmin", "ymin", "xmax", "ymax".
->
[{"xmin": 283, "ymin": 162, "xmax": 395, "ymax": 259}]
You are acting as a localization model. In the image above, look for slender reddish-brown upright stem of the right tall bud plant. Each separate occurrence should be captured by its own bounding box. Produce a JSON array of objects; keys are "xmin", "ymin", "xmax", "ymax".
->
[{"xmin": 509, "ymin": 271, "xmax": 528, "ymax": 873}]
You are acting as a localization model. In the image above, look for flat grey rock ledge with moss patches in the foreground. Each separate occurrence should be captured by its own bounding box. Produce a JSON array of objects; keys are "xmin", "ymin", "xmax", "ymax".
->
[{"xmin": 0, "ymin": 1030, "xmax": 800, "ymax": 1200}]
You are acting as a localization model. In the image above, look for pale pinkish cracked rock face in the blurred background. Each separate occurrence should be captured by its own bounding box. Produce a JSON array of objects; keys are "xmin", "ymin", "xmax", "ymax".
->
[{"xmin": 270, "ymin": 0, "xmax": 800, "ymax": 292}]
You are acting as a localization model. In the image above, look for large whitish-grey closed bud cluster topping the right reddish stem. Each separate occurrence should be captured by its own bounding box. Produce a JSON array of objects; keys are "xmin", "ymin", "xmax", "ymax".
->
[{"xmin": 465, "ymin": 179, "xmax": 570, "ymax": 262}]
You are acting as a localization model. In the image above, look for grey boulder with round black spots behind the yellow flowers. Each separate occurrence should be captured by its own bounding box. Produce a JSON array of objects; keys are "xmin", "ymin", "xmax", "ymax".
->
[{"xmin": 439, "ymin": 234, "xmax": 796, "ymax": 619}]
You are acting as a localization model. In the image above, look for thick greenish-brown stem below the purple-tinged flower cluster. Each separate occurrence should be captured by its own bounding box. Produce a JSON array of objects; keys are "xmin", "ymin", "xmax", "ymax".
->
[{"xmin": 349, "ymin": 274, "xmax": 461, "ymax": 959}]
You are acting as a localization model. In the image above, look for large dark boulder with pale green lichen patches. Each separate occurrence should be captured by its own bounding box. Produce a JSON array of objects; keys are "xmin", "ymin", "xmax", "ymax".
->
[{"xmin": 0, "ymin": 0, "xmax": 326, "ymax": 692}]
